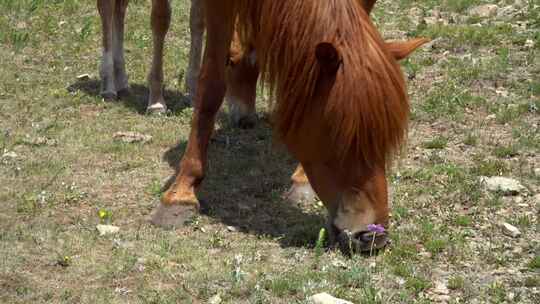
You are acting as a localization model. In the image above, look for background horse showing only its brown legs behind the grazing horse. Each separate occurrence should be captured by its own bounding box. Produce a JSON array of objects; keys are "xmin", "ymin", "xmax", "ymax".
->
[{"xmin": 97, "ymin": 0, "xmax": 258, "ymax": 123}]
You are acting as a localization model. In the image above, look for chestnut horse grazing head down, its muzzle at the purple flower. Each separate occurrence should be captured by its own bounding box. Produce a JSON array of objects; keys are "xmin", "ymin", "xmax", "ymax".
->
[{"xmin": 152, "ymin": 0, "xmax": 426, "ymax": 252}]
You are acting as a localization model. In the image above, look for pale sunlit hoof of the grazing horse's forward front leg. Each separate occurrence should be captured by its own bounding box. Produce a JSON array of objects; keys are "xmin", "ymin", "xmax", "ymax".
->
[{"xmin": 150, "ymin": 203, "xmax": 199, "ymax": 229}]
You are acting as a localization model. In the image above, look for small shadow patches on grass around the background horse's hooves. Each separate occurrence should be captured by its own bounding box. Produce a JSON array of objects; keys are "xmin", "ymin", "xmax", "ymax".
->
[{"xmin": 67, "ymin": 79, "xmax": 189, "ymax": 114}]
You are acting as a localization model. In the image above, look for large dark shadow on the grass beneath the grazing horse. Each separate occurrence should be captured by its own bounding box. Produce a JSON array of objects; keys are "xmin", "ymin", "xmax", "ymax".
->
[{"xmin": 163, "ymin": 121, "xmax": 325, "ymax": 247}]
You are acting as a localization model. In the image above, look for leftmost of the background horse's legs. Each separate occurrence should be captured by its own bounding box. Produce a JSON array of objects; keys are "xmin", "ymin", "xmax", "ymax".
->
[{"xmin": 97, "ymin": 0, "xmax": 116, "ymax": 100}]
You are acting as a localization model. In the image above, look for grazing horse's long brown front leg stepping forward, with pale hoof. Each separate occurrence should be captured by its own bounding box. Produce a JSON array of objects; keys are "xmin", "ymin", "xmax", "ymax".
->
[{"xmin": 152, "ymin": 0, "xmax": 234, "ymax": 227}]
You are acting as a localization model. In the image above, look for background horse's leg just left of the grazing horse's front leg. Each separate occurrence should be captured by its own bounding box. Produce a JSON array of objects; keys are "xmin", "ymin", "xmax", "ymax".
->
[{"xmin": 185, "ymin": 0, "xmax": 204, "ymax": 101}]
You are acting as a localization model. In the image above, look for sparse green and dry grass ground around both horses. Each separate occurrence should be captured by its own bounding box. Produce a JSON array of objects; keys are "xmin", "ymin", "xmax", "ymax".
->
[{"xmin": 0, "ymin": 0, "xmax": 540, "ymax": 304}]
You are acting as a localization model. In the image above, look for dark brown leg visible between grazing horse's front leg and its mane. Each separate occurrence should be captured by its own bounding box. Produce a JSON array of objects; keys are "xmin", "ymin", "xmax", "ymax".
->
[{"xmin": 225, "ymin": 42, "xmax": 259, "ymax": 129}]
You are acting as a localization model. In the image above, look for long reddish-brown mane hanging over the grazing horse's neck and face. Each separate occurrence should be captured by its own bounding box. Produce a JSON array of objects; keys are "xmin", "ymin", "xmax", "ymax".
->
[{"xmin": 237, "ymin": 0, "xmax": 409, "ymax": 167}]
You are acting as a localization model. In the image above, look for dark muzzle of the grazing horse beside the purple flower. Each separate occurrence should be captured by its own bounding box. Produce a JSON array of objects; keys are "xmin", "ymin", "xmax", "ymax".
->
[{"xmin": 337, "ymin": 230, "xmax": 389, "ymax": 255}]
